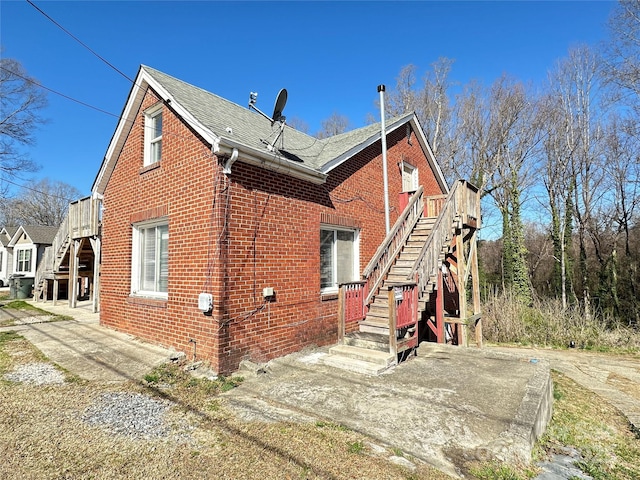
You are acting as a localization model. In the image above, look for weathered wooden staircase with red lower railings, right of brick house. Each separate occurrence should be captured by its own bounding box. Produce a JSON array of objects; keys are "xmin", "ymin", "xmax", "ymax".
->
[{"xmin": 325, "ymin": 181, "xmax": 479, "ymax": 375}]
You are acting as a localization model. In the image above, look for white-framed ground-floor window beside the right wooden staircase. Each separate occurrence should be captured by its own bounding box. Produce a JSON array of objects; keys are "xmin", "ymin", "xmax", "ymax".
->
[{"xmin": 320, "ymin": 226, "xmax": 360, "ymax": 292}]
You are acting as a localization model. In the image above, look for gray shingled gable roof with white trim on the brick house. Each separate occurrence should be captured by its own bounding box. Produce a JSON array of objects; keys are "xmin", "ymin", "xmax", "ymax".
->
[{"xmin": 92, "ymin": 65, "xmax": 448, "ymax": 194}]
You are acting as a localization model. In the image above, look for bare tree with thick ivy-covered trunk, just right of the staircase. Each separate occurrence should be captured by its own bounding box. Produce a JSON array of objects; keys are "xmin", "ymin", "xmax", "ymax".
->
[{"xmin": 458, "ymin": 76, "xmax": 540, "ymax": 302}]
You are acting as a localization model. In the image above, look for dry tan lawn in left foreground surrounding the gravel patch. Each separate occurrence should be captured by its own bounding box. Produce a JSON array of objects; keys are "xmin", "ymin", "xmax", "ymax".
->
[{"xmin": 0, "ymin": 333, "xmax": 450, "ymax": 480}]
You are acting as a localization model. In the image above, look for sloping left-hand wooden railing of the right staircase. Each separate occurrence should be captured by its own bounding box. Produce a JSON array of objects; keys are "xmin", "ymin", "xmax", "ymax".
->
[{"xmin": 362, "ymin": 187, "xmax": 424, "ymax": 305}]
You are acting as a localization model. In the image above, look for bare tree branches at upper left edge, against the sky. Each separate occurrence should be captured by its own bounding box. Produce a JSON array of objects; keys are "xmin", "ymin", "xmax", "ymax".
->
[{"xmin": 0, "ymin": 58, "xmax": 46, "ymax": 197}]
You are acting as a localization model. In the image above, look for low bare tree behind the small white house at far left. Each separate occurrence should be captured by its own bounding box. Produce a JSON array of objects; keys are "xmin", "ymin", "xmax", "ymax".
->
[{"xmin": 0, "ymin": 178, "xmax": 80, "ymax": 227}]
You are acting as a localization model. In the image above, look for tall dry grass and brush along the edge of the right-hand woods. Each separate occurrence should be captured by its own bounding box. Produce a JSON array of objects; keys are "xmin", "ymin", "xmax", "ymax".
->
[{"xmin": 482, "ymin": 292, "xmax": 640, "ymax": 352}]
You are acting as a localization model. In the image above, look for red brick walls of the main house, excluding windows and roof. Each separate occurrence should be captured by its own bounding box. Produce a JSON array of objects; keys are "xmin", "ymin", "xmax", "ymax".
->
[{"xmin": 101, "ymin": 89, "xmax": 441, "ymax": 373}]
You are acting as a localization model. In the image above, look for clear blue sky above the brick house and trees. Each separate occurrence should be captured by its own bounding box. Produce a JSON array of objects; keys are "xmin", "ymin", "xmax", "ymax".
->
[{"xmin": 0, "ymin": 0, "xmax": 615, "ymax": 194}]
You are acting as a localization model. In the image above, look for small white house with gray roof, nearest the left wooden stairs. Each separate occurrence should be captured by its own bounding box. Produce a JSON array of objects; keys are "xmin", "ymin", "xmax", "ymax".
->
[{"xmin": 8, "ymin": 225, "xmax": 58, "ymax": 278}]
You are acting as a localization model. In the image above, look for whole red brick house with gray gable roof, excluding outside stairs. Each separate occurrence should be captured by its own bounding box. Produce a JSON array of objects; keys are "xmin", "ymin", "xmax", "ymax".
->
[{"xmin": 93, "ymin": 66, "xmax": 479, "ymax": 373}]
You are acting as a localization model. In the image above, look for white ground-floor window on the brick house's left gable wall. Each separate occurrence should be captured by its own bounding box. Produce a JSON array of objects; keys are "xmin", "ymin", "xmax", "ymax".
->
[{"xmin": 131, "ymin": 220, "xmax": 169, "ymax": 298}]
